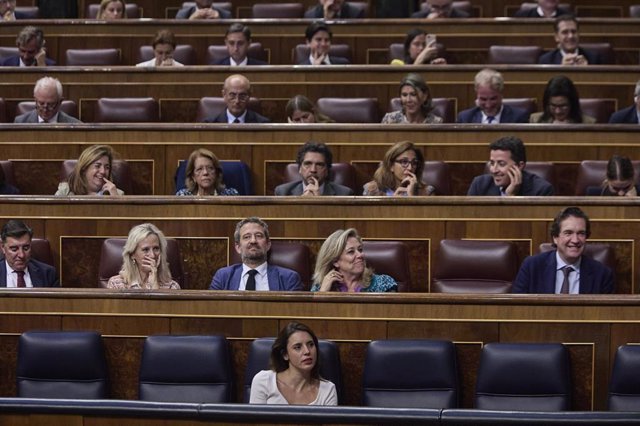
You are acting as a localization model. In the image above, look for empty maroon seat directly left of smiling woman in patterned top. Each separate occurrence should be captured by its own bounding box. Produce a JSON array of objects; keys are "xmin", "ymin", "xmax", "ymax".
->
[{"xmin": 317, "ymin": 98, "xmax": 380, "ymax": 123}]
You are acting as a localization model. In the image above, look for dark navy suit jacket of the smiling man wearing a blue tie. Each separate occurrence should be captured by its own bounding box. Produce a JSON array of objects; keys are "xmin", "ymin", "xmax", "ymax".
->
[{"xmin": 511, "ymin": 250, "xmax": 614, "ymax": 294}]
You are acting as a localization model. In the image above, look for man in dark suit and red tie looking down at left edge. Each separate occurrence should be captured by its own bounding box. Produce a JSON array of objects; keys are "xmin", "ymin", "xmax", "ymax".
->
[{"xmin": 0, "ymin": 219, "xmax": 60, "ymax": 288}]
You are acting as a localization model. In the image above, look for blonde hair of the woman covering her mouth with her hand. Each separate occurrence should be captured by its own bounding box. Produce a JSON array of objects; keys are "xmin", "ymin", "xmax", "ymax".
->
[{"xmin": 120, "ymin": 223, "xmax": 171, "ymax": 288}]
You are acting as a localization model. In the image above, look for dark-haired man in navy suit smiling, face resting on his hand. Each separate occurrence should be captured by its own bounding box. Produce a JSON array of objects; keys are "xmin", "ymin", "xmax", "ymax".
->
[{"xmin": 467, "ymin": 136, "xmax": 554, "ymax": 196}]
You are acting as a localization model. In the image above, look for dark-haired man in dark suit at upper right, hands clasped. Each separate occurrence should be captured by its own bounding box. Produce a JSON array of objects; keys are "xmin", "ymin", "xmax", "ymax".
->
[{"xmin": 538, "ymin": 15, "xmax": 602, "ymax": 65}]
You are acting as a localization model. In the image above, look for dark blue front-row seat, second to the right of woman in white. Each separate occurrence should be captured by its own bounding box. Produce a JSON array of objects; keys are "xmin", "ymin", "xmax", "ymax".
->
[{"xmin": 475, "ymin": 343, "xmax": 571, "ymax": 411}]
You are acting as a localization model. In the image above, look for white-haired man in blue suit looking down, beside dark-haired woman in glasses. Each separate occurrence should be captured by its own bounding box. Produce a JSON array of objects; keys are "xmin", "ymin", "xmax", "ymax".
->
[{"xmin": 457, "ymin": 68, "xmax": 529, "ymax": 124}]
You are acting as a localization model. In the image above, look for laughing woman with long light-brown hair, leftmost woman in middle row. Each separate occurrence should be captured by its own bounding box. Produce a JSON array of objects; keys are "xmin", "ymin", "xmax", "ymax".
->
[{"xmin": 55, "ymin": 145, "xmax": 124, "ymax": 196}]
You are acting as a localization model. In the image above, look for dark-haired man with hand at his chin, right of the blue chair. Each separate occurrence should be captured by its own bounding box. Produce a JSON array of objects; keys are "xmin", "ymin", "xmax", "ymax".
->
[{"xmin": 275, "ymin": 141, "xmax": 353, "ymax": 196}]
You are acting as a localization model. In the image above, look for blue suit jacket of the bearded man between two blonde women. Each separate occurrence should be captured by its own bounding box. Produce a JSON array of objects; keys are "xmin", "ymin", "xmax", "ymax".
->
[{"xmin": 209, "ymin": 263, "xmax": 302, "ymax": 291}]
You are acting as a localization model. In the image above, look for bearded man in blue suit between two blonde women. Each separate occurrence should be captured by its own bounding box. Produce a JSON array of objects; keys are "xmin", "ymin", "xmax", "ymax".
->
[{"xmin": 209, "ymin": 217, "xmax": 302, "ymax": 291}]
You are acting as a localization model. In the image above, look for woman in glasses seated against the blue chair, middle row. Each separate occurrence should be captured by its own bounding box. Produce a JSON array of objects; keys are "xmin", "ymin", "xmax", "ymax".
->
[{"xmin": 176, "ymin": 148, "xmax": 238, "ymax": 196}]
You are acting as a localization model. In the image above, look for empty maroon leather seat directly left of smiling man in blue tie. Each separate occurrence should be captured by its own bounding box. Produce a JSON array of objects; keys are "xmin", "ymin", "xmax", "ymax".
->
[{"xmin": 431, "ymin": 240, "xmax": 519, "ymax": 293}]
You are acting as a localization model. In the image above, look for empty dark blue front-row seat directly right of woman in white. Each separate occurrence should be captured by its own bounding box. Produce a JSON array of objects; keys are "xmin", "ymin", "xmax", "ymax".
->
[{"xmin": 362, "ymin": 340, "xmax": 460, "ymax": 409}]
